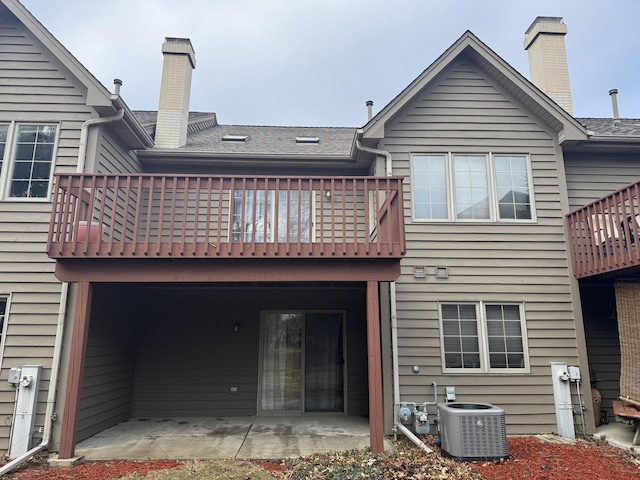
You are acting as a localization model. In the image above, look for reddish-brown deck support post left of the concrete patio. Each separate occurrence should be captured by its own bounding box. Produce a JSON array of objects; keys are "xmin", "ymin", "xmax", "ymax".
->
[{"xmin": 58, "ymin": 282, "xmax": 93, "ymax": 459}]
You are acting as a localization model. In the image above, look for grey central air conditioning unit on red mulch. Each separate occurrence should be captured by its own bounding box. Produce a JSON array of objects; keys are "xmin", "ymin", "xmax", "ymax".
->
[{"xmin": 438, "ymin": 402, "xmax": 509, "ymax": 461}]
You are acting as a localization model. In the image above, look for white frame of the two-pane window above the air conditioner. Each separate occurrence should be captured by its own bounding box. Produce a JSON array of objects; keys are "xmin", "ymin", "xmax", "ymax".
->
[{"xmin": 438, "ymin": 300, "xmax": 531, "ymax": 374}]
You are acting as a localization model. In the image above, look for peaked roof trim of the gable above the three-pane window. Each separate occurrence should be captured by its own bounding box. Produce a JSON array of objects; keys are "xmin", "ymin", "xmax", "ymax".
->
[{"xmin": 363, "ymin": 31, "xmax": 587, "ymax": 142}]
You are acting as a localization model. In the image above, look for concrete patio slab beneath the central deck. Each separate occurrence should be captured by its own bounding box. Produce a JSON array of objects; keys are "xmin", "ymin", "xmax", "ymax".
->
[{"xmin": 76, "ymin": 415, "xmax": 390, "ymax": 460}]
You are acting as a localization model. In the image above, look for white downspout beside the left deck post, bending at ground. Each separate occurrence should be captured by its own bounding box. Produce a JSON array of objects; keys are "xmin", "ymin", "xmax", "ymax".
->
[{"xmin": 0, "ymin": 282, "xmax": 69, "ymax": 477}]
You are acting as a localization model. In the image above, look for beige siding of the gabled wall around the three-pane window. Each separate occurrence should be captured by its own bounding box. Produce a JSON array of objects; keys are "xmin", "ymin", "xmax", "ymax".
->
[{"xmin": 380, "ymin": 59, "xmax": 578, "ymax": 434}]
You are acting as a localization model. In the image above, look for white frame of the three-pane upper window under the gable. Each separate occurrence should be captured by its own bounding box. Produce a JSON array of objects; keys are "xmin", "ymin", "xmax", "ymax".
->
[{"xmin": 410, "ymin": 152, "xmax": 537, "ymax": 223}]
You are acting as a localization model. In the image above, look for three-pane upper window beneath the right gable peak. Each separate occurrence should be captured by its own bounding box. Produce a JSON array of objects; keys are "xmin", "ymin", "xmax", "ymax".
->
[{"xmin": 411, "ymin": 154, "xmax": 534, "ymax": 221}]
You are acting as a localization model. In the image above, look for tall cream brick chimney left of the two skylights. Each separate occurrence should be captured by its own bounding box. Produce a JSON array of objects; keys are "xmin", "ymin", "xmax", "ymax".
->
[{"xmin": 155, "ymin": 37, "xmax": 196, "ymax": 148}]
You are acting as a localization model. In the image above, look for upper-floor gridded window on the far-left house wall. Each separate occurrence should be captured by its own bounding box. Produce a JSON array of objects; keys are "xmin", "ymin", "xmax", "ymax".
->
[{"xmin": 0, "ymin": 123, "xmax": 58, "ymax": 199}]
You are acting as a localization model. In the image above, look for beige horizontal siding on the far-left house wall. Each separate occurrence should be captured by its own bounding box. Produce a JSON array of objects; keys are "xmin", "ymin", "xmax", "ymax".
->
[{"xmin": 0, "ymin": 14, "xmax": 95, "ymax": 450}]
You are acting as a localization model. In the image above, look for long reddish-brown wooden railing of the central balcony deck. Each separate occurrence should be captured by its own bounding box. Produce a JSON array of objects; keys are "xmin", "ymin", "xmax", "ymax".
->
[{"xmin": 47, "ymin": 174, "xmax": 405, "ymax": 258}]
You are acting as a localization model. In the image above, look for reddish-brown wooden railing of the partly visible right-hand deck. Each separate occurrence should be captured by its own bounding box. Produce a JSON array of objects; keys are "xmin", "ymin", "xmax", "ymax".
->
[{"xmin": 567, "ymin": 182, "xmax": 640, "ymax": 278}]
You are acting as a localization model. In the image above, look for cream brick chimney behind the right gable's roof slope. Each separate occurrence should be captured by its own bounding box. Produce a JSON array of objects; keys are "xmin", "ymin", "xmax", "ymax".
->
[{"xmin": 524, "ymin": 17, "xmax": 573, "ymax": 115}]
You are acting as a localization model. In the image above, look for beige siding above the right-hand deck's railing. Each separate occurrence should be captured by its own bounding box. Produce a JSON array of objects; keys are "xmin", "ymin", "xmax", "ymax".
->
[{"xmin": 564, "ymin": 152, "xmax": 640, "ymax": 211}]
